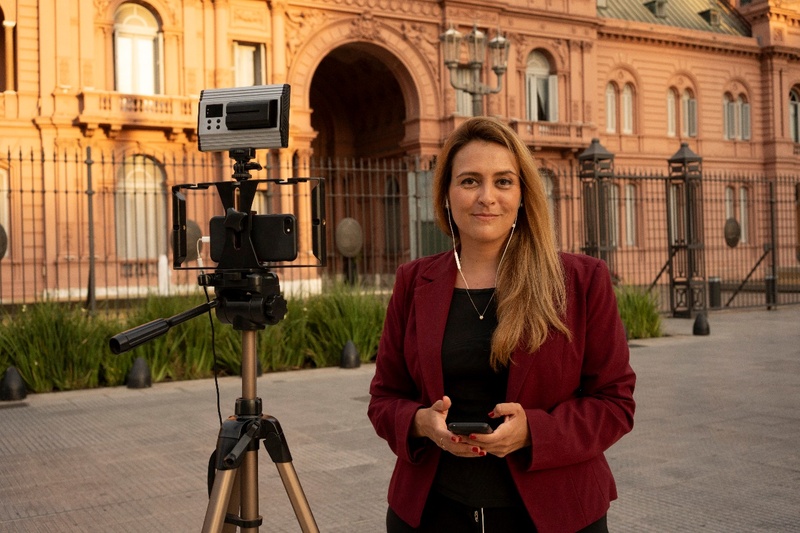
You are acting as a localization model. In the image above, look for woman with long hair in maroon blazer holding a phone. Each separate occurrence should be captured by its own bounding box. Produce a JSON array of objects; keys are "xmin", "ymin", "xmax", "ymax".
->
[{"xmin": 368, "ymin": 117, "xmax": 635, "ymax": 533}]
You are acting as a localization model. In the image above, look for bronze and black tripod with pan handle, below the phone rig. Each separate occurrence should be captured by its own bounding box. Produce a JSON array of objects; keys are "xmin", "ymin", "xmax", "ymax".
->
[{"xmin": 109, "ymin": 269, "xmax": 319, "ymax": 533}]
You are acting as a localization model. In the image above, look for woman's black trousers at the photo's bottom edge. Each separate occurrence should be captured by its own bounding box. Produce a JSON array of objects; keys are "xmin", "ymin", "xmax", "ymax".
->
[{"xmin": 386, "ymin": 493, "xmax": 608, "ymax": 533}]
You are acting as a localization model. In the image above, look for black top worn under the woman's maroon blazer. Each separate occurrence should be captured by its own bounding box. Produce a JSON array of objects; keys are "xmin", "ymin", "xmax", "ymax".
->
[{"xmin": 434, "ymin": 289, "xmax": 519, "ymax": 507}]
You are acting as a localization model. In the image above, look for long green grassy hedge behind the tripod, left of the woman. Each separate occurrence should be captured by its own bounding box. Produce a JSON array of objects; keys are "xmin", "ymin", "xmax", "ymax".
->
[{"xmin": 0, "ymin": 287, "xmax": 387, "ymax": 392}]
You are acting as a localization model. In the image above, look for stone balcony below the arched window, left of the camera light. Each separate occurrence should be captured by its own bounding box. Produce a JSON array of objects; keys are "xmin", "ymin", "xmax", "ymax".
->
[{"xmin": 78, "ymin": 90, "xmax": 197, "ymax": 136}]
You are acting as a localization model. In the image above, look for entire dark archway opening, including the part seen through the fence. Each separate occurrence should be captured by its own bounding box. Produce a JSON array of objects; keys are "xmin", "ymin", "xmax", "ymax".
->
[{"xmin": 309, "ymin": 42, "xmax": 409, "ymax": 285}]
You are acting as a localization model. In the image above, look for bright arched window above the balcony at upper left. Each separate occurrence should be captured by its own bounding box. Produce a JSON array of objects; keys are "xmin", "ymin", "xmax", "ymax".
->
[{"xmin": 114, "ymin": 3, "xmax": 163, "ymax": 95}]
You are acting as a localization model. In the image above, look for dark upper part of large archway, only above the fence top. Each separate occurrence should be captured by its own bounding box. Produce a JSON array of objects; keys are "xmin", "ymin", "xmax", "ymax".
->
[{"xmin": 309, "ymin": 42, "xmax": 406, "ymax": 159}]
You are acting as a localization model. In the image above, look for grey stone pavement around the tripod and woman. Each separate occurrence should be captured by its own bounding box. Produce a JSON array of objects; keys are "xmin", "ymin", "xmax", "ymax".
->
[{"xmin": 0, "ymin": 307, "xmax": 800, "ymax": 533}]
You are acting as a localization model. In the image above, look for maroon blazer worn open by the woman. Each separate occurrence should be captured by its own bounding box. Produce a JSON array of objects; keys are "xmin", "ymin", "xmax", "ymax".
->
[{"xmin": 368, "ymin": 252, "xmax": 636, "ymax": 533}]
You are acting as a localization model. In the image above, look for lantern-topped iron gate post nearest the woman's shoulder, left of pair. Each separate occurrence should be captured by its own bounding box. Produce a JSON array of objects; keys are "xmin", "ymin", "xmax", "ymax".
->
[{"xmin": 578, "ymin": 139, "xmax": 616, "ymax": 275}]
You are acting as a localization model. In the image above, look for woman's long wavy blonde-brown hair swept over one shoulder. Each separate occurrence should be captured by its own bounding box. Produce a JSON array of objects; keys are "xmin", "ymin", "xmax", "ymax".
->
[{"xmin": 433, "ymin": 117, "xmax": 571, "ymax": 369}]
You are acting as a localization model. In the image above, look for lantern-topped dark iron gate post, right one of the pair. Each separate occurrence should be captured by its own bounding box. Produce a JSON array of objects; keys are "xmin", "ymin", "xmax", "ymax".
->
[{"xmin": 666, "ymin": 143, "xmax": 707, "ymax": 318}]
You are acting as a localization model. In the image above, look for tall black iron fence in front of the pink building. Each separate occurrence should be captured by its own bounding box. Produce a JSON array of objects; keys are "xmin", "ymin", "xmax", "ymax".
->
[{"xmin": 0, "ymin": 150, "xmax": 800, "ymax": 313}]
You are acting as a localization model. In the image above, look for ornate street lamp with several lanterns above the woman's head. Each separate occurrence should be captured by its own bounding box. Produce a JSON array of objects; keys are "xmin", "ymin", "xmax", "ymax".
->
[{"xmin": 439, "ymin": 24, "xmax": 509, "ymax": 117}]
